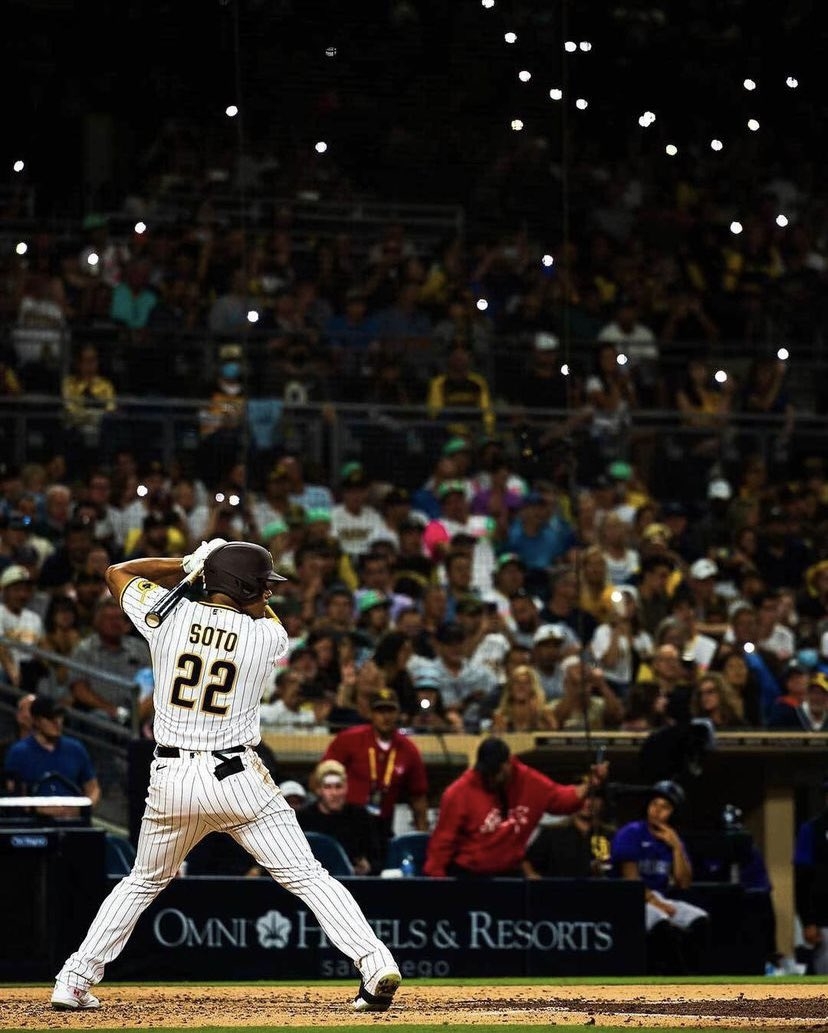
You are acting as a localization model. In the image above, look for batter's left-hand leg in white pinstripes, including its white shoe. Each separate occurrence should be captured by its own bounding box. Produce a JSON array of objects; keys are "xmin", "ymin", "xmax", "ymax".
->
[{"xmin": 52, "ymin": 759, "xmax": 215, "ymax": 1009}]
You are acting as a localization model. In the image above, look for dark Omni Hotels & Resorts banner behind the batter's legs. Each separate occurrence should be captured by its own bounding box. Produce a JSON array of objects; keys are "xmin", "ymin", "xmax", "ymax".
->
[{"xmin": 107, "ymin": 878, "xmax": 644, "ymax": 980}]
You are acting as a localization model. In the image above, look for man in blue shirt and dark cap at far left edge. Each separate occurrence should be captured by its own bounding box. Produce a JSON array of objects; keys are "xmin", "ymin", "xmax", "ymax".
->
[{"xmin": 5, "ymin": 696, "xmax": 100, "ymax": 818}]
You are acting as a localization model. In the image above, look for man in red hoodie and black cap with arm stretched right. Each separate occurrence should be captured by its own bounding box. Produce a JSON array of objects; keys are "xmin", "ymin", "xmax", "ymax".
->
[{"xmin": 423, "ymin": 737, "xmax": 608, "ymax": 877}]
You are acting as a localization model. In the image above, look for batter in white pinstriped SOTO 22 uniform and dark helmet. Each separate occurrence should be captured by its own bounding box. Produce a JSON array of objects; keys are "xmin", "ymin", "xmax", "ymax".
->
[{"xmin": 52, "ymin": 538, "xmax": 400, "ymax": 1011}]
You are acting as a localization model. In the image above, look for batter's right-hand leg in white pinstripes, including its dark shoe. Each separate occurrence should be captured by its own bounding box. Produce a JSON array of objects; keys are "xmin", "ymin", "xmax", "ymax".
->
[{"xmin": 222, "ymin": 754, "xmax": 400, "ymax": 1010}]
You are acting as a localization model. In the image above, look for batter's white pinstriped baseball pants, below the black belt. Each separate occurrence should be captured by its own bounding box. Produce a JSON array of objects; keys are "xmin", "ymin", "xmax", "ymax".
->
[{"xmin": 57, "ymin": 749, "xmax": 394, "ymax": 990}]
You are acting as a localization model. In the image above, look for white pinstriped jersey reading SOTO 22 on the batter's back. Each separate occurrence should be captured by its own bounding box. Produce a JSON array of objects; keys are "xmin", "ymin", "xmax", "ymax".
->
[{"xmin": 120, "ymin": 577, "xmax": 288, "ymax": 750}]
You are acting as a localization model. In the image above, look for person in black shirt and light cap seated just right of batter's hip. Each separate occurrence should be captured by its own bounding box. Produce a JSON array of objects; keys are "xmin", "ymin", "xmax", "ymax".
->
[{"xmin": 296, "ymin": 760, "xmax": 383, "ymax": 875}]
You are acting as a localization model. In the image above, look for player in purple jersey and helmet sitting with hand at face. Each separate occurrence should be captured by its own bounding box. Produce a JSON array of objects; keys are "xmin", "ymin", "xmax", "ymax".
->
[{"xmin": 610, "ymin": 781, "xmax": 709, "ymax": 975}]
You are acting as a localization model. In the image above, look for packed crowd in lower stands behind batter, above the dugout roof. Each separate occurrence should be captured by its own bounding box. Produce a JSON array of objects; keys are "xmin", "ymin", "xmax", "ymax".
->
[{"xmin": 0, "ymin": 423, "xmax": 828, "ymax": 772}]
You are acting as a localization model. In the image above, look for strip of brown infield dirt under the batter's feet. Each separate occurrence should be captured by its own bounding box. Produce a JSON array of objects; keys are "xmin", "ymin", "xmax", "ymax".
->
[{"xmin": 0, "ymin": 982, "xmax": 828, "ymax": 1031}]
